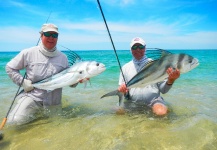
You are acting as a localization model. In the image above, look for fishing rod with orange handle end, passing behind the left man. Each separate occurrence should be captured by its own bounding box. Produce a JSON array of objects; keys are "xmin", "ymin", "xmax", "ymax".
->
[{"xmin": 0, "ymin": 11, "xmax": 52, "ymax": 140}]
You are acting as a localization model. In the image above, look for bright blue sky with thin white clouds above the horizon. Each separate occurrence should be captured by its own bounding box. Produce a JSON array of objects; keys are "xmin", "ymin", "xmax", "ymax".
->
[{"xmin": 0, "ymin": 0, "xmax": 217, "ymax": 51}]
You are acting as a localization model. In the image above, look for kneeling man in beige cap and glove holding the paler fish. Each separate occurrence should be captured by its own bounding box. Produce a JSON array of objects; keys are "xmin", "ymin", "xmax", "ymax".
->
[{"xmin": 6, "ymin": 24, "xmax": 78, "ymax": 125}]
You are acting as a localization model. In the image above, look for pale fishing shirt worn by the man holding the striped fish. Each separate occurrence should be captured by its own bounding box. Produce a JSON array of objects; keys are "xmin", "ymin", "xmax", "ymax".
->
[{"xmin": 119, "ymin": 58, "xmax": 172, "ymax": 104}]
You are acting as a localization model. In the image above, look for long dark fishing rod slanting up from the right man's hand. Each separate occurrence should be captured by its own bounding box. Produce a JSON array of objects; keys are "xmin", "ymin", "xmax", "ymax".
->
[{"xmin": 97, "ymin": 0, "xmax": 127, "ymax": 85}]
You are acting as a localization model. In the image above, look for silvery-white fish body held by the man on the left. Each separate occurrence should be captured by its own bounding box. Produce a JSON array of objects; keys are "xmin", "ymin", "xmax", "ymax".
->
[{"xmin": 33, "ymin": 61, "xmax": 106, "ymax": 91}]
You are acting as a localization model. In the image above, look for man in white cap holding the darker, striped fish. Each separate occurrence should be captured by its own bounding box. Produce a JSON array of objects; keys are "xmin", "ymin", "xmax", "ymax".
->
[{"xmin": 118, "ymin": 37, "xmax": 180, "ymax": 116}]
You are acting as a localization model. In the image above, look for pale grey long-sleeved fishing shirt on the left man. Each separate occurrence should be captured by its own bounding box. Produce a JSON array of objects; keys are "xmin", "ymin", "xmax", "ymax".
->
[{"xmin": 6, "ymin": 45, "xmax": 68, "ymax": 106}]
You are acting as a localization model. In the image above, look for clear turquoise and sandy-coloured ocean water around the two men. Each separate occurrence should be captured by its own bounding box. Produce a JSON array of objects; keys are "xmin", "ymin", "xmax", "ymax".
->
[{"xmin": 0, "ymin": 49, "xmax": 217, "ymax": 150}]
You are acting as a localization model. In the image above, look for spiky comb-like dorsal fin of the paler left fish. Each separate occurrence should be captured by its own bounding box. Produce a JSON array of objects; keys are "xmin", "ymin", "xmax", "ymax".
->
[{"xmin": 60, "ymin": 45, "xmax": 82, "ymax": 66}]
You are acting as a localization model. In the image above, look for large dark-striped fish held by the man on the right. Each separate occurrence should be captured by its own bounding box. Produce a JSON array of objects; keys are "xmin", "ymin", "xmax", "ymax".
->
[{"xmin": 101, "ymin": 53, "xmax": 199, "ymax": 105}]
